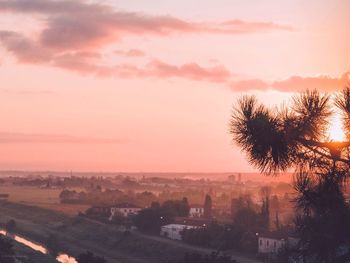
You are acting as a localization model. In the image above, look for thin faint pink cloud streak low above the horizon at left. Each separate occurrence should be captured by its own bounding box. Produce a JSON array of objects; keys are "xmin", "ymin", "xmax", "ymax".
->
[{"xmin": 0, "ymin": 132, "xmax": 129, "ymax": 144}]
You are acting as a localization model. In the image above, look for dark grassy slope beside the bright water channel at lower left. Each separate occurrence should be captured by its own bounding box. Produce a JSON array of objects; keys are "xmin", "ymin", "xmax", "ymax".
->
[{"xmin": 0, "ymin": 202, "xmax": 216, "ymax": 263}]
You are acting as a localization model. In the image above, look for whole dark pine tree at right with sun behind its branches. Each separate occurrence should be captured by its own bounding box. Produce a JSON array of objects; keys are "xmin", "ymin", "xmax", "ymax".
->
[{"xmin": 230, "ymin": 87, "xmax": 350, "ymax": 263}]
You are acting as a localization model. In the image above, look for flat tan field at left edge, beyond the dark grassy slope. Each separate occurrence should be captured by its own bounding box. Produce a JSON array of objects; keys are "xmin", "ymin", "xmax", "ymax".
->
[{"xmin": 0, "ymin": 185, "xmax": 89, "ymax": 215}]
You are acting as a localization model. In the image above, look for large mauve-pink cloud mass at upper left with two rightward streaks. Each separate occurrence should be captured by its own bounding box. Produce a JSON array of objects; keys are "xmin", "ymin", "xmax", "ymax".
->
[{"xmin": 0, "ymin": 0, "xmax": 293, "ymax": 82}]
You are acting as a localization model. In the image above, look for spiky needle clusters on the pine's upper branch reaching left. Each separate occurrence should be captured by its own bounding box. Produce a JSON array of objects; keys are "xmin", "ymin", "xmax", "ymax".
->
[{"xmin": 230, "ymin": 90, "xmax": 342, "ymax": 173}]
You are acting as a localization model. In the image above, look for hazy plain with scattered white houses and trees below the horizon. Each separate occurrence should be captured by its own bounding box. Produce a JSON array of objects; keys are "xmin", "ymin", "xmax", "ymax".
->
[{"xmin": 0, "ymin": 172, "xmax": 293, "ymax": 262}]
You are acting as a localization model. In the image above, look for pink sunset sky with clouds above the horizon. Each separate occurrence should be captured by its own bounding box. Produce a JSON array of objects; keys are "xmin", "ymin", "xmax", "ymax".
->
[{"xmin": 0, "ymin": 0, "xmax": 350, "ymax": 172}]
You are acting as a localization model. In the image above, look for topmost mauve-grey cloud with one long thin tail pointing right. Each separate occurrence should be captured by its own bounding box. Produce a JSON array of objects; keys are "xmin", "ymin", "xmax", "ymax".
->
[{"xmin": 0, "ymin": 0, "xmax": 293, "ymax": 50}]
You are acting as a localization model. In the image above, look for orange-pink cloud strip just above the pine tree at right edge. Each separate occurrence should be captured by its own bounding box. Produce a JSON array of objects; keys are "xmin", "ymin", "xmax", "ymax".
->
[{"xmin": 230, "ymin": 71, "xmax": 350, "ymax": 92}]
